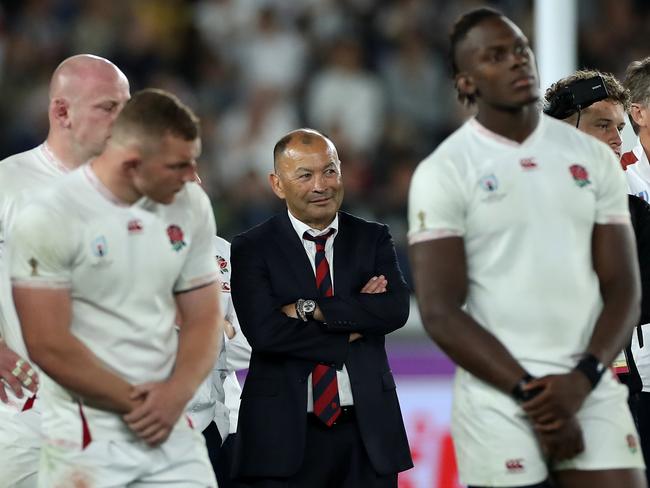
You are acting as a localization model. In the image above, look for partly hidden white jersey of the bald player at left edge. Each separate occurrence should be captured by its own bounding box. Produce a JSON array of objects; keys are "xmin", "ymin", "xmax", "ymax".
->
[{"xmin": 0, "ymin": 144, "xmax": 68, "ymax": 358}]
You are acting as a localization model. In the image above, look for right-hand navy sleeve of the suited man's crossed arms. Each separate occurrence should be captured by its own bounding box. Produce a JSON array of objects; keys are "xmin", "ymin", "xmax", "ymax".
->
[{"xmin": 317, "ymin": 225, "xmax": 410, "ymax": 335}]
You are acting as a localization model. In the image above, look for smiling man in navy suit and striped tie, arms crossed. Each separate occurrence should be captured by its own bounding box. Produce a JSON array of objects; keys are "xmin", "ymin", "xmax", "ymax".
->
[{"xmin": 231, "ymin": 129, "xmax": 413, "ymax": 488}]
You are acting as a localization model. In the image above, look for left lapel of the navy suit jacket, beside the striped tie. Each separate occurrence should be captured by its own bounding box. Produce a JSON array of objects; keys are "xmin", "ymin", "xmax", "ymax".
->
[{"xmin": 273, "ymin": 212, "xmax": 318, "ymax": 297}]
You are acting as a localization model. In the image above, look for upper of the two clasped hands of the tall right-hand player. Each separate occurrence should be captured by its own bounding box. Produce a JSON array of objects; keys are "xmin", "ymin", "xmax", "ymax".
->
[{"xmin": 521, "ymin": 371, "xmax": 591, "ymax": 427}]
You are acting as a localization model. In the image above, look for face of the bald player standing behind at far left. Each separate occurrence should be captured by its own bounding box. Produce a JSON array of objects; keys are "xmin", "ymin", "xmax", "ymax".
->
[{"xmin": 69, "ymin": 73, "xmax": 129, "ymax": 158}]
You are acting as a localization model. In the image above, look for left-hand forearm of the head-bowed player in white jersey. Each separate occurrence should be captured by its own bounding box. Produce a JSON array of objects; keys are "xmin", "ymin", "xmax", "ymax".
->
[{"xmin": 28, "ymin": 335, "xmax": 135, "ymax": 413}]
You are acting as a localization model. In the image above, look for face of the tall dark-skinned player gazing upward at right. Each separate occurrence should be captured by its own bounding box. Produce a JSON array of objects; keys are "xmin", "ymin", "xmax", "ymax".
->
[{"xmin": 456, "ymin": 17, "xmax": 539, "ymax": 110}]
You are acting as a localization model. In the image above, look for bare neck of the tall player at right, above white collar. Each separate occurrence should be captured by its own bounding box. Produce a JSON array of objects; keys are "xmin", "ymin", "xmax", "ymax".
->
[{"xmin": 476, "ymin": 103, "xmax": 540, "ymax": 143}]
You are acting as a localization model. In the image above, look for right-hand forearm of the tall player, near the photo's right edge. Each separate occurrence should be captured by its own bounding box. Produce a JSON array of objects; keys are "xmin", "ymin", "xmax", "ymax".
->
[{"xmin": 586, "ymin": 278, "xmax": 641, "ymax": 366}]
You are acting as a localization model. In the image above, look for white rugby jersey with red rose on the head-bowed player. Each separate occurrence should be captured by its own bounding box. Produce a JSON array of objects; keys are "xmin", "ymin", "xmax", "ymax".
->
[{"xmin": 9, "ymin": 165, "xmax": 217, "ymax": 438}]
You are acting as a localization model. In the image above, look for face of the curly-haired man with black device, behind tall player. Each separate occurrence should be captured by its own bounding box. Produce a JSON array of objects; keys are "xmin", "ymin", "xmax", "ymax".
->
[{"xmin": 578, "ymin": 100, "xmax": 625, "ymax": 158}]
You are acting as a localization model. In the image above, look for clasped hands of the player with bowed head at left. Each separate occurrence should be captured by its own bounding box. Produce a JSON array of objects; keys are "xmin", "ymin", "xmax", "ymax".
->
[{"xmin": 123, "ymin": 381, "xmax": 189, "ymax": 447}]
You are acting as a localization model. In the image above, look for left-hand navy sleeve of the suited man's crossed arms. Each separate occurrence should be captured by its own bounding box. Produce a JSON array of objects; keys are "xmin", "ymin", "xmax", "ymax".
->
[{"xmin": 230, "ymin": 236, "xmax": 349, "ymax": 367}]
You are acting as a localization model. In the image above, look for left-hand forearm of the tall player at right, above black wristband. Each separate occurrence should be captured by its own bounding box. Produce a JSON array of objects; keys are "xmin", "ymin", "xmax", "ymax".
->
[{"xmin": 420, "ymin": 307, "xmax": 526, "ymax": 394}]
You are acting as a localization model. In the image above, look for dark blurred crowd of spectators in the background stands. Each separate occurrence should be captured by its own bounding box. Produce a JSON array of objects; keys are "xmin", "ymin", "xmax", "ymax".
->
[{"xmin": 0, "ymin": 0, "xmax": 650, "ymax": 286}]
